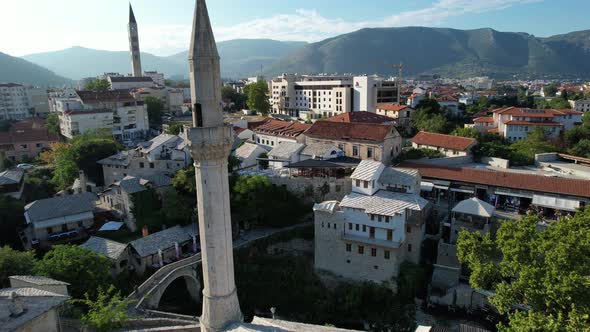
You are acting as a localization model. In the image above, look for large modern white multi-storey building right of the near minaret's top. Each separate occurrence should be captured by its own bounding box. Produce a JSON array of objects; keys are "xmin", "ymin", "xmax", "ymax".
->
[{"xmin": 270, "ymin": 74, "xmax": 397, "ymax": 120}]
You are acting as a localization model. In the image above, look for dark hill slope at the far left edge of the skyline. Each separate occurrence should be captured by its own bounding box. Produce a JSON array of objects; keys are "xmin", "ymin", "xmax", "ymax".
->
[{"xmin": 0, "ymin": 52, "xmax": 72, "ymax": 87}]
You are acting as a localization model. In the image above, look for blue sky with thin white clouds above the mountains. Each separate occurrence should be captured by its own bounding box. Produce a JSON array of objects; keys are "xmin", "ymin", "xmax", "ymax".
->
[{"xmin": 0, "ymin": 0, "xmax": 590, "ymax": 56}]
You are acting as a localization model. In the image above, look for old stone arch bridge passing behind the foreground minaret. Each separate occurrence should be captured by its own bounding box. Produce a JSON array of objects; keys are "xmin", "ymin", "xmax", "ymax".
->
[{"xmin": 129, "ymin": 222, "xmax": 313, "ymax": 310}]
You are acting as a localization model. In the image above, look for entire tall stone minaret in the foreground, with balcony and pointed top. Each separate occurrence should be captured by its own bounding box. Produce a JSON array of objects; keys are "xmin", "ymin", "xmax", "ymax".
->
[{"xmin": 187, "ymin": 0, "xmax": 242, "ymax": 332}]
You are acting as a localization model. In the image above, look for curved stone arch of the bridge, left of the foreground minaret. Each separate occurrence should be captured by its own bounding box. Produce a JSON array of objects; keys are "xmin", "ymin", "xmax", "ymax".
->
[{"xmin": 146, "ymin": 265, "xmax": 201, "ymax": 309}]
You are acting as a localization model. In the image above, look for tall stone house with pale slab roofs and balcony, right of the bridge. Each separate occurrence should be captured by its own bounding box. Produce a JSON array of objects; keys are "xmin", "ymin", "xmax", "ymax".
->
[{"xmin": 314, "ymin": 160, "xmax": 430, "ymax": 282}]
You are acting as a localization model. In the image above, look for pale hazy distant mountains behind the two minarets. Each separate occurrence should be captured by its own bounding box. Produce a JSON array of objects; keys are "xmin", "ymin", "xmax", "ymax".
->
[{"xmin": 24, "ymin": 39, "xmax": 305, "ymax": 80}]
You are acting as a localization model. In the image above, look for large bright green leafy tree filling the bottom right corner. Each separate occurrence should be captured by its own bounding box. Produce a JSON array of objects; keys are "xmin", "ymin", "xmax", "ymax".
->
[{"xmin": 458, "ymin": 207, "xmax": 590, "ymax": 332}]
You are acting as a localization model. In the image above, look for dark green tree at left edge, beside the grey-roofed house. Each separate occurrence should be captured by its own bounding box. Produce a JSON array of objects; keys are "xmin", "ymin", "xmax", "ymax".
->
[{"xmin": 0, "ymin": 195, "xmax": 25, "ymax": 248}]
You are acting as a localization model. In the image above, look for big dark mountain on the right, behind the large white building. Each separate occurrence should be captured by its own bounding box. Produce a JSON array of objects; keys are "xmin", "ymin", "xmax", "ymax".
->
[{"xmin": 265, "ymin": 27, "xmax": 590, "ymax": 78}]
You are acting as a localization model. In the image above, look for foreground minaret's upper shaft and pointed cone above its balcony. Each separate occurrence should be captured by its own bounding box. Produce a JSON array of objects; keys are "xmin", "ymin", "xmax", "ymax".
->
[{"xmin": 188, "ymin": 0, "xmax": 223, "ymax": 127}]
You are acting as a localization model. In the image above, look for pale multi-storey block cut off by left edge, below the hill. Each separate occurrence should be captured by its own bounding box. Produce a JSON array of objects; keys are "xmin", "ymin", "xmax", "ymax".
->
[{"xmin": 0, "ymin": 83, "xmax": 33, "ymax": 120}]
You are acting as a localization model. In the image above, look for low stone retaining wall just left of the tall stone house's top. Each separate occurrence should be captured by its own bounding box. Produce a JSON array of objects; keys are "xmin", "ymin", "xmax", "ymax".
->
[{"xmin": 269, "ymin": 177, "xmax": 352, "ymax": 203}]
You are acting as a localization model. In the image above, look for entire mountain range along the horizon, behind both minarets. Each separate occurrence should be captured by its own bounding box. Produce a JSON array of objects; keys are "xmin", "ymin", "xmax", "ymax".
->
[{"xmin": 0, "ymin": 27, "xmax": 590, "ymax": 86}]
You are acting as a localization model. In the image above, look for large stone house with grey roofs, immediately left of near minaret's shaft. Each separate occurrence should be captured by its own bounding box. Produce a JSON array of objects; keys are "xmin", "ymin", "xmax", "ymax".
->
[{"xmin": 98, "ymin": 134, "xmax": 191, "ymax": 186}]
